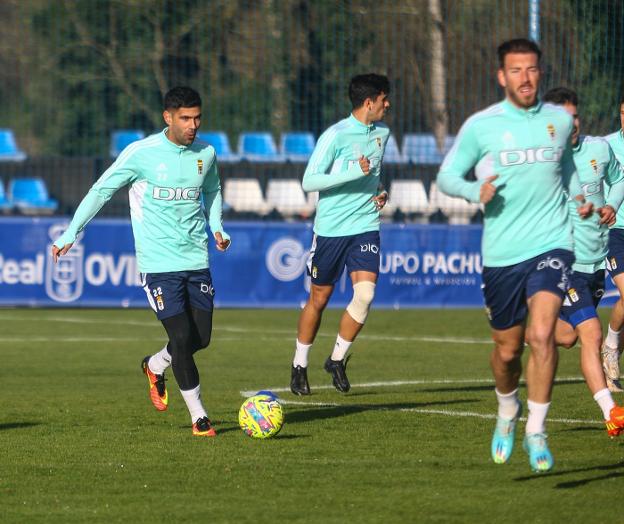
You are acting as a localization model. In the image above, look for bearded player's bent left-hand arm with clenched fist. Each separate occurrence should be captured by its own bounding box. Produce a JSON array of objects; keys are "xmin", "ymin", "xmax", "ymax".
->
[{"xmin": 437, "ymin": 120, "xmax": 488, "ymax": 203}]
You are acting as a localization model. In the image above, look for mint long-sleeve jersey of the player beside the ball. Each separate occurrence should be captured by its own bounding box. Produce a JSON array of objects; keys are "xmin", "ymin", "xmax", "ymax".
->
[{"xmin": 54, "ymin": 129, "xmax": 229, "ymax": 273}]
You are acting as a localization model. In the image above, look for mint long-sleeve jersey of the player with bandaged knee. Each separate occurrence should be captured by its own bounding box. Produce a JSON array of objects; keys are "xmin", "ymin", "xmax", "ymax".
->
[{"xmin": 302, "ymin": 115, "xmax": 390, "ymax": 237}]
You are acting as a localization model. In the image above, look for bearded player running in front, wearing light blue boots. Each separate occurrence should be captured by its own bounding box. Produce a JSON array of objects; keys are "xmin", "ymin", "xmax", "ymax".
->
[{"xmin": 437, "ymin": 39, "xmax": 592, "ymax": 471}]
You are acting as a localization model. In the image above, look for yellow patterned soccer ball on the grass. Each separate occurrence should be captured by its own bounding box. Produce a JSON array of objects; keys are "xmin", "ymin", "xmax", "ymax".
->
[{"xmin": 238, "ymin": 391, "xmax": 284, "ymax": 438}]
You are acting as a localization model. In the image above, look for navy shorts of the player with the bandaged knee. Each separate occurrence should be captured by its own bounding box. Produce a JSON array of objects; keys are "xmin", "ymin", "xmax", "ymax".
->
[{"xmin": 308, "ymin": 231, "xmax": 379, "ymax": 286}]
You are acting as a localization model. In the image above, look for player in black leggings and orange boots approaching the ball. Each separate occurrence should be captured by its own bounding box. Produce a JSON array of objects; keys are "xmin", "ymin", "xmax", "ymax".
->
[{"xmin": 52, "ymin": 87, "xmax": 230, "ymax": 437}]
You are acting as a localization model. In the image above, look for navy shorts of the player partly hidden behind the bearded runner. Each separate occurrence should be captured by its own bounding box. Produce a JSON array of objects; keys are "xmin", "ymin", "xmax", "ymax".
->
[{"xmin": 559, "ymin": 269, "xmax": 605, "ymax": 328}]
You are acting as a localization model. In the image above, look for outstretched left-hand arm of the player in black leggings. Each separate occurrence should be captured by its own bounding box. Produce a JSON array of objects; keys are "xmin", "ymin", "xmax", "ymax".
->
[{"xmin": 52, "ymin": 155, "xmax": 136, "ymax": 262}]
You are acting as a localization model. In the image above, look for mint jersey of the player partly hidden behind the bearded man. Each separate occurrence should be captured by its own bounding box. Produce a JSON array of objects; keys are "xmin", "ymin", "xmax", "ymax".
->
[{"xmin": 568, "ymin": 136, "xmax": 624, "ymax": 273}]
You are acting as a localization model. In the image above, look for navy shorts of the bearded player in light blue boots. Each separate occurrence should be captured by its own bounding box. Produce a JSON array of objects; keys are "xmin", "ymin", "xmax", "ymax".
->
[{"xmin": 481, "ymin": 249, "xmax": 574, "ymax": 329}]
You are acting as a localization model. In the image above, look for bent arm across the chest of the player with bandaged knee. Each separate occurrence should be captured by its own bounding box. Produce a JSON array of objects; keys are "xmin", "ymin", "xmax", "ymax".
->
[{"xmin": 301, "ymin": 130, "xmax": 370, "ymax": 192}]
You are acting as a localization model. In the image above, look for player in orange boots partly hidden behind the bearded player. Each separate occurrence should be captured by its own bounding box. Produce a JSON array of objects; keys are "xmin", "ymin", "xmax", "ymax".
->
[{"xmin": 542, "ymin": 87, "xmax": 624, "ymax": 437}]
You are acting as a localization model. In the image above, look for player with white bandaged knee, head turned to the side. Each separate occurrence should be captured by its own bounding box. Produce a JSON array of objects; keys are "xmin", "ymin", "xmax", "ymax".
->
[{"xmin": 290, "ymin": 74, "xmax": 390, "ymax": 395}]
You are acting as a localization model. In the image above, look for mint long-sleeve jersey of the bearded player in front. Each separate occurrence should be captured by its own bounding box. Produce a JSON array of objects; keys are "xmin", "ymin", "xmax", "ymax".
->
[{"xmin": 437, "ymin": 100, "xmax": 581, "ymax": 267}]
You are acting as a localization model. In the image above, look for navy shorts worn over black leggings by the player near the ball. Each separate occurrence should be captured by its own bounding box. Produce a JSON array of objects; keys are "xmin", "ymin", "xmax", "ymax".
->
[{"xmin": 142, "ymin": 268, "xmax": 214, "ymax": 320}]
